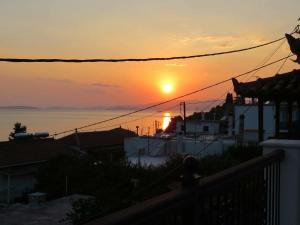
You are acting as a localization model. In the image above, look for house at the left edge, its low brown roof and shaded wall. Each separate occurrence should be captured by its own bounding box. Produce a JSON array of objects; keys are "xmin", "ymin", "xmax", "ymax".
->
[{"xmin": 0, "ymin": 138, "xmax": 71, "ymax": 203}]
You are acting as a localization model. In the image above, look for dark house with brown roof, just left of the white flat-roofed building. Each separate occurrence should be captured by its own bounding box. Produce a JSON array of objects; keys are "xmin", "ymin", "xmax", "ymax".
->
[{"xmin": 57, "ymin": 127, "xmax": 137, "ymax": 160}]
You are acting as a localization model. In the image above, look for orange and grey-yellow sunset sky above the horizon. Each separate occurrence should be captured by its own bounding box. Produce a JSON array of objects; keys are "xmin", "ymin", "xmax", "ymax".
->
[{"xmin": 0, "ymin": 0, "xmax": 300, "ymax": 107}]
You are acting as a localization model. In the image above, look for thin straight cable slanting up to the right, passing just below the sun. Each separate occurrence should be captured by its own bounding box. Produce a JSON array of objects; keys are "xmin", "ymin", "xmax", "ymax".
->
[{"xmin": 52, "ymin": 55, "xmax": 292, "ymax": 136}]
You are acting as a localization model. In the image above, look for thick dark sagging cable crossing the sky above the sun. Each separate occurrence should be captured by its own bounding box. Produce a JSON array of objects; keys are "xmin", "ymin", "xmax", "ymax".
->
[{"xmin": 0, "ymin": 37, "xmax": 285, "ymax": 63}]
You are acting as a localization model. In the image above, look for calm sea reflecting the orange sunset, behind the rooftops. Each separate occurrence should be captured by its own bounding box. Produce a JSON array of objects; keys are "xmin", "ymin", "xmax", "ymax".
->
[{"xmin": 0, "ymin": 109, "xmax": 173, "ymax": 141}]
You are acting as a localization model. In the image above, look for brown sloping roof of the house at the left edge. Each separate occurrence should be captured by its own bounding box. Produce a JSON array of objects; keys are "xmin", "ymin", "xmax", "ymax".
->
[{"xmin": 0, "ymin": 139, "xmax": 70, "ymax": 168}]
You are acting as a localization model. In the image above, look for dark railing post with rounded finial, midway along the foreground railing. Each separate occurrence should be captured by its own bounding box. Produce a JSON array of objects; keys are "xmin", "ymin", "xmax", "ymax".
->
[{"xmin": 181, "ymin": 155, "xmax": 200, "ymax": 225}]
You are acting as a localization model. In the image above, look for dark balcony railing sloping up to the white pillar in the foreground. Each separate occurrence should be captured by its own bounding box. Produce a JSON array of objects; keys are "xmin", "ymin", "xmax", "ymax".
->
[{"xmin": 87, "ymin": 150, "xmax": 284, "ymax": 225}]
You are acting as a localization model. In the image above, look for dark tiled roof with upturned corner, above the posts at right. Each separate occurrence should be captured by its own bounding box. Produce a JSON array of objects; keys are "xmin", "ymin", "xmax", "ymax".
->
[{"xmin": 232, "ymin": 70, "xmax": 300, "ymax": 100}]
